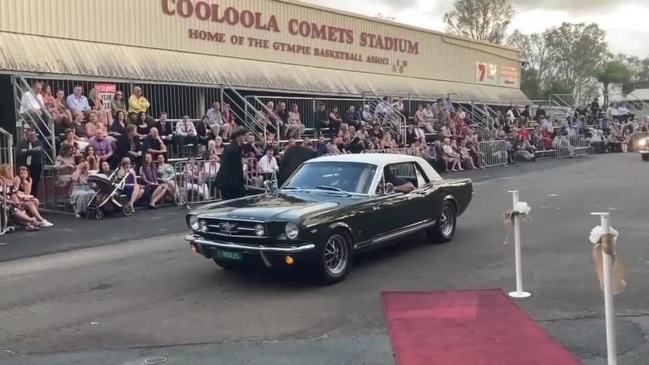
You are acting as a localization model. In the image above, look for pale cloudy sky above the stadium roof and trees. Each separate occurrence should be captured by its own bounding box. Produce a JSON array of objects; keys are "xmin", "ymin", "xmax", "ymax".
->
[{"xmin": 303, "ymin": 0, "xmax": 649, "ymax": 58}]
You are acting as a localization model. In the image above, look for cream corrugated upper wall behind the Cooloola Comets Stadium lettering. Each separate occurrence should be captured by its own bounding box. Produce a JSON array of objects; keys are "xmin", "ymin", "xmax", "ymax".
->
[{"xmin": 0, "ymin": 0, "xmax": 519, "ymax": 86}]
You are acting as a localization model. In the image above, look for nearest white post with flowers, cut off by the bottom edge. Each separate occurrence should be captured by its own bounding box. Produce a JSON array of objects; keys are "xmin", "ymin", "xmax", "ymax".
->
[{"xmin": 590, "ymin": 212, "xmax": 617, "ymax": 365}]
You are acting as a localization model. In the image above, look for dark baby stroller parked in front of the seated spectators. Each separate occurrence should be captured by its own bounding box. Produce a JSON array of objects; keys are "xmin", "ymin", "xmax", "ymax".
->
[{"xmin": 86, "ymin": 171, "xmax": 133, "ymax": 221}]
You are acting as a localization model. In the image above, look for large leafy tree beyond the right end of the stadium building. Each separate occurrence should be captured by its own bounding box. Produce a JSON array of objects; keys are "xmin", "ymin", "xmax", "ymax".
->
[{"xmin": 543, "ymin": 23, "xmax": 607, "ymax": 100}]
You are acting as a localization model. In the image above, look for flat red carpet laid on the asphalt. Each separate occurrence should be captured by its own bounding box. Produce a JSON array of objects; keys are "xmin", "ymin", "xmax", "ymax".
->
[{"xmin": 383, "ymin": 290, "xmax": 581, "ymax": 365}]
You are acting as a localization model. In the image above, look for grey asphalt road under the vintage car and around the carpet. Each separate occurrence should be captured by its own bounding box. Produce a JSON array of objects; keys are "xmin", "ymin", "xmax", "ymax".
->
[{"xmin": 0, "ymin": 154, "xmax": 649, "ymax": 365}]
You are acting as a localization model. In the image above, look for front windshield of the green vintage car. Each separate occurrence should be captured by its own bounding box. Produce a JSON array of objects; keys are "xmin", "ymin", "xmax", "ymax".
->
[{"xmin": 283, "ymin": 162, "xmax": 376, "ymax": 194}]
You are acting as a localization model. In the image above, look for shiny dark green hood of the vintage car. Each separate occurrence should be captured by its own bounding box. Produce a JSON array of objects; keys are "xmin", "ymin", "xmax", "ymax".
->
[{"xmin": 195, "ymin": 192, "xmax": 359, "ymax": 222}]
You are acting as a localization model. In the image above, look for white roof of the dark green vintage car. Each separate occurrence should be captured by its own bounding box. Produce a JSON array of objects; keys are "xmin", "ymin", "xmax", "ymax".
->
[{"xmin": 305, "ymin": 153, "xmax": 442, "ymax": 180}]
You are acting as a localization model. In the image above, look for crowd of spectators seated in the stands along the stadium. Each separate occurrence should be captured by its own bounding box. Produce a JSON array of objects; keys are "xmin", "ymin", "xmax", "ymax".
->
[{"xmin": 12, "ymin": 82, "xmax": 647, "ymax": 228}]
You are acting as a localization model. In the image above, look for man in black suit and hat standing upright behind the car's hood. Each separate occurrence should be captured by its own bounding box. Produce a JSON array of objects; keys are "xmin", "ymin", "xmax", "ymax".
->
[{"xmin": 216, "ymin": 128, "xmax": 248, "ymax": 200}]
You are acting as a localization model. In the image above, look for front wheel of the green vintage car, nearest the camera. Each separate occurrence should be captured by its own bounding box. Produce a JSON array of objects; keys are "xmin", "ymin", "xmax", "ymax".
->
[{"xmin": 313, "ymin": 231, "xmax": 353, "ymax": 285}]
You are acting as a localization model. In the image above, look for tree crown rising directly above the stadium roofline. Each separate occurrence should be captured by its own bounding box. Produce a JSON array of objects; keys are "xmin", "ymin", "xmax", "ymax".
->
[{"xmin": 444, "ymin": 0, "xmax": 515, "ymax": 44}]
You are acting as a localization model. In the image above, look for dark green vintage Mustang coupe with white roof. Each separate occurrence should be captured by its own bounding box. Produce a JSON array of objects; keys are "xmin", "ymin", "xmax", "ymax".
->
[{"xmin": 186, "ymin": 154, "xmax": 473, "ymax": 283}]
